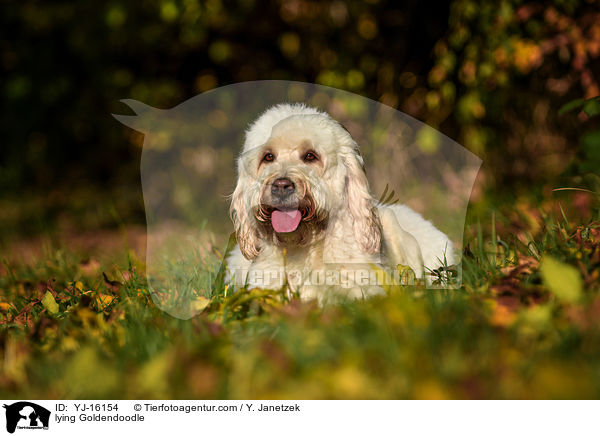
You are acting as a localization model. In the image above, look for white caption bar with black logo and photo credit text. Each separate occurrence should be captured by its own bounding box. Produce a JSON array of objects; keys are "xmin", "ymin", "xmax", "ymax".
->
[{"xmin": 0, "ymin": 400, "xmax": 600, "ymax": 436}]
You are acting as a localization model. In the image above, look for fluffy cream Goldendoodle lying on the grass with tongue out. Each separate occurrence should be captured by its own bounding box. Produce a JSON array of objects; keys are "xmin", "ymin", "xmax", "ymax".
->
[{"xmin": 227, "ymin": 104, "xmax": 455, "ymax": 300}]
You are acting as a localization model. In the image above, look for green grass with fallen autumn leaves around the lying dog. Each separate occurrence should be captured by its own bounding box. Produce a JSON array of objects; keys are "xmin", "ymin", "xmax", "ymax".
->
[{"xmin": 0, "ymin": 196, "xmax": 600, "ymax": 399}]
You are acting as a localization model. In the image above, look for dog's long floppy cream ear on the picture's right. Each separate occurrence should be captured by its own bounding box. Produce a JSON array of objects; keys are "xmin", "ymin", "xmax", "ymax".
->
[{"xmin": 342, "ymin": 140, "xmax": 381, "ymax": 254}]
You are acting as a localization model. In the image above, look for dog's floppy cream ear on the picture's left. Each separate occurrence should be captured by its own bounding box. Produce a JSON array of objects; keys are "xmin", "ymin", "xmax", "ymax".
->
[{"xmin": 229, "ymin": 176, "xmax": 259, "ymax": 260}]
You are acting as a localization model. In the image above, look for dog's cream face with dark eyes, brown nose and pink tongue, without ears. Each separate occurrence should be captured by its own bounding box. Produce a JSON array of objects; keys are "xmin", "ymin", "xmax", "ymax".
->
[{"xmin": 250, "ymin": 117, "xmax": 343, "ymax": 246}]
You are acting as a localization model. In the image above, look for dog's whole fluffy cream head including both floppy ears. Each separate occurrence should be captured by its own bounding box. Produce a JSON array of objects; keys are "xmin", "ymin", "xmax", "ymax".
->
[{"xmin": 231, "ymin": 105, "xmax": 380, "ymax": 259}]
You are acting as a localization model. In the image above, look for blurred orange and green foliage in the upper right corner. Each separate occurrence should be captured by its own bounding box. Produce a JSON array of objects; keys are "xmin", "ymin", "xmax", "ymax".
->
[{"xmin": 424, "ymin": 0, "xmax": 600, "ymax": 189}]
